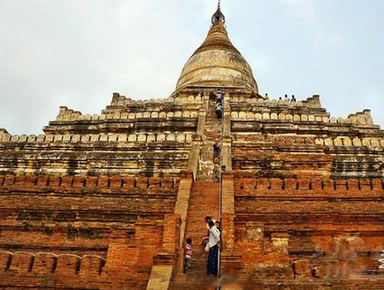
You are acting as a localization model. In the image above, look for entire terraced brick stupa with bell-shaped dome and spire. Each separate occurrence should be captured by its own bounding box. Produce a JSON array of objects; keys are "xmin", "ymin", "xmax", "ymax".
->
[{"xmin": 0, "ymin": 5, "xmax": 384, "ymax": 290}]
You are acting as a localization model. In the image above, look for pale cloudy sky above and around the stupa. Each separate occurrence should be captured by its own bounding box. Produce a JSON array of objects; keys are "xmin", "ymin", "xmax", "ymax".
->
[{"xmin": 0, "ymin": 0, "xmax": 384, "ymax": 135}]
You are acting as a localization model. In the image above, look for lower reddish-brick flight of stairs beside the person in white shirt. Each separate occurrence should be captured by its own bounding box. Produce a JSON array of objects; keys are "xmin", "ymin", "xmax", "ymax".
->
[{"xmin": 169, "ymin": 181, "xmax": 219, "ymax": 290}]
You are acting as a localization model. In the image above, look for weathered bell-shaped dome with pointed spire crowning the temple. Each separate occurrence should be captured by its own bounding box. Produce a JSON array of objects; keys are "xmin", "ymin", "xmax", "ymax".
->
[{"xmin": 176, "ymin": 7, "xmax": 258, "ymax": 93}]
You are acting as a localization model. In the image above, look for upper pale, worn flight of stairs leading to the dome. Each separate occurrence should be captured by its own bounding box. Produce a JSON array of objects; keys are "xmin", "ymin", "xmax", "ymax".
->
[{"xmin": 197, "ymin": 101, "xmax": 222, "ymax": 182}]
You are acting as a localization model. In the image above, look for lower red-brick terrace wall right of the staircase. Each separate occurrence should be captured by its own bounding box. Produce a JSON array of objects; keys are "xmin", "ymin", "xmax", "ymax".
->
[{"xmin": 234, "ymin": 174, "xmax": 384, "ymax": 281}]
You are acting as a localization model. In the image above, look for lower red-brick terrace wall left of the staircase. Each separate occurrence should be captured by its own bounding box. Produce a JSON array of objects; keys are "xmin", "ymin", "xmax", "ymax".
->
[{"xmin": 0, "ymin": 174, "xmax": 180, "ymax": 290}]
